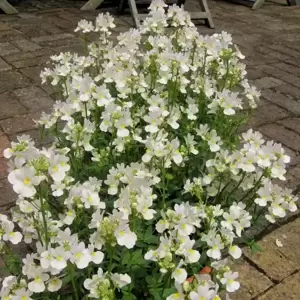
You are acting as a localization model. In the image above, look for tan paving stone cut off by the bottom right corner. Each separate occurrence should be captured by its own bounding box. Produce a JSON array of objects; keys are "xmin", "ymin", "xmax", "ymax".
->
[{"xmin": 258, "ymin": 272, "xmax": 300, "ymax": 300}]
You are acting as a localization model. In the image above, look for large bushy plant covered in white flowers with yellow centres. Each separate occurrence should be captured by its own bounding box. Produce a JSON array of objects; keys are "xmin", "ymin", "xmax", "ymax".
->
[{"xmin": 0, "ymin": 1, "xmax": 297, "ymax": 300}]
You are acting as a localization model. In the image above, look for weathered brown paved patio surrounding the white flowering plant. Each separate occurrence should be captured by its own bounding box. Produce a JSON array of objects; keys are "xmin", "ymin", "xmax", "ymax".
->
[{"xmin": 0, "ymin": 0, "xmax": 300, "ymax": 300}]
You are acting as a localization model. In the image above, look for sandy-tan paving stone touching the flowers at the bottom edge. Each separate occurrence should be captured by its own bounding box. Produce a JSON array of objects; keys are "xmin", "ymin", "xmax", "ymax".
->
[{"xmin": 230, "ymin": 259, "xmax": 273, "ymax": 300}]
